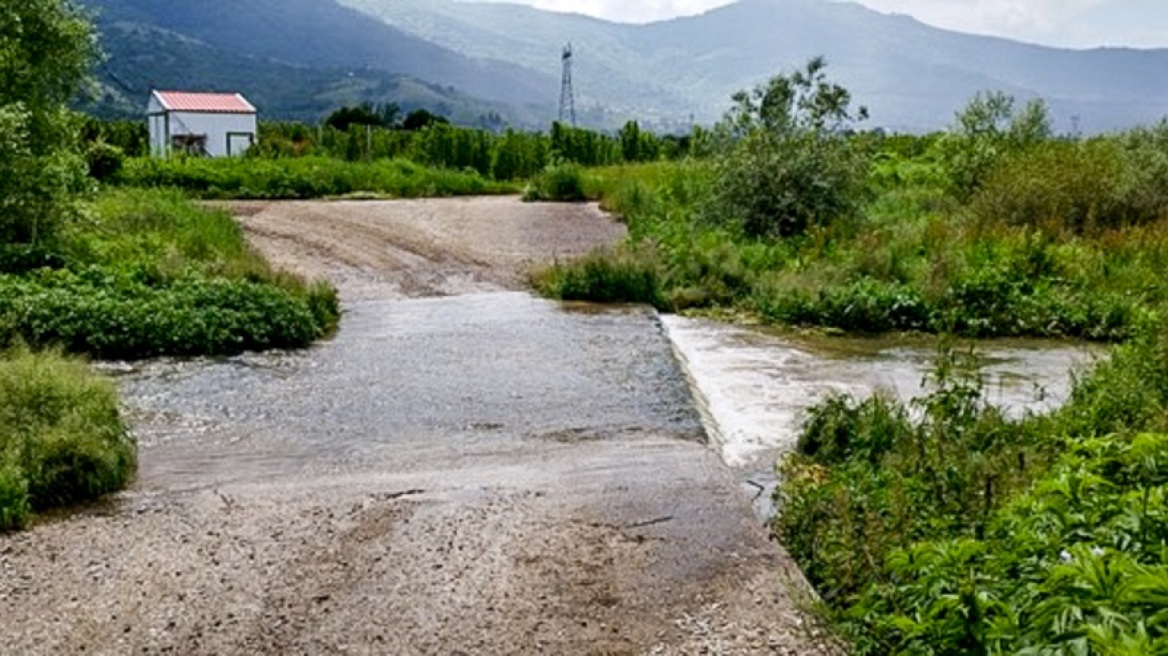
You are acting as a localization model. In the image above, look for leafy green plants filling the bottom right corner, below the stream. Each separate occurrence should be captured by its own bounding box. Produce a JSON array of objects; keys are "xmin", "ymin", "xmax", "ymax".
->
[{"xmin": 774, "ymin": 329, "xmax": 1168, "ymax": 654}]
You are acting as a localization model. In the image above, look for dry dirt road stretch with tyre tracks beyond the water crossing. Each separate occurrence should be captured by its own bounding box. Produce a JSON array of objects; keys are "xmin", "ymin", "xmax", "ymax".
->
[{"xmin": 228, "ymin": 197, "xmax": 625, "ymax": 302}]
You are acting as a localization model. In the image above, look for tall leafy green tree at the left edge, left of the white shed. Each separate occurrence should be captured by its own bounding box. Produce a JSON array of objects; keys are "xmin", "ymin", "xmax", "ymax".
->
[{"xmin": 0, "ymin": 0, "xmax": 98, "ymax": 243}]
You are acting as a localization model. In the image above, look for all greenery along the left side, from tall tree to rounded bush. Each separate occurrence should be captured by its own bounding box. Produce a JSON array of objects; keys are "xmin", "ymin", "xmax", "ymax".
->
[{"xmin": 0, "ymin": 0, "xmax": 339, "ymax": 531}]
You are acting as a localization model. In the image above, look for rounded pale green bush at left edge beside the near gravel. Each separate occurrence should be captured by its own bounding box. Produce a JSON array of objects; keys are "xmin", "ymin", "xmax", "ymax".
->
[{"xmin": 0, "ymin": 349, "xmax": 137, "ymax": 530}]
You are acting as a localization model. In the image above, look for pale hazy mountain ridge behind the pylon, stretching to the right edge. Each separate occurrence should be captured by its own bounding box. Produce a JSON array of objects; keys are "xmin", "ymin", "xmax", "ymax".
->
[{"xmin": 340, "ymin": 0, "xmax": 1168, "ymax": 132}]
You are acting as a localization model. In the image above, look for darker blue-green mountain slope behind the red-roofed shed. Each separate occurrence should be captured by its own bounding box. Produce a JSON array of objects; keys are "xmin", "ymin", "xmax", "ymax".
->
[{"xmin": 83, "ymin": 0, "xmax": 558, "ymax": 123}]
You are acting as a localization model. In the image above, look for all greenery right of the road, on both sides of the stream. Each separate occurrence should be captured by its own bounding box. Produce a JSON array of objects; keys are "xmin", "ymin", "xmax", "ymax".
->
[{"xmin": 534, "ymin": 61, "xmax": 1168, "ymax": 655}]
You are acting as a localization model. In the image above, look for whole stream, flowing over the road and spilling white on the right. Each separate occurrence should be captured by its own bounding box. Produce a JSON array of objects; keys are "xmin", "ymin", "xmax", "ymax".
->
[{"xmin": 107, "ymin": 293, "xmax": 1098, "ymax": 515}]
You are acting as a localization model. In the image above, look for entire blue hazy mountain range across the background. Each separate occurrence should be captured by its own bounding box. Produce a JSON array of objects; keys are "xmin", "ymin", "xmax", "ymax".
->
[{"xmin": 77, "ymin": 0, "xmax": 1168, "ymax": 133}]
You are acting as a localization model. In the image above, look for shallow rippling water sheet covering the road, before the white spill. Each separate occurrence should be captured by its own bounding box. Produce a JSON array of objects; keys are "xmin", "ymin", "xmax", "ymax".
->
[{"xmin": 116, "ymin": 293, "xmax": 702, "ymax": 490}]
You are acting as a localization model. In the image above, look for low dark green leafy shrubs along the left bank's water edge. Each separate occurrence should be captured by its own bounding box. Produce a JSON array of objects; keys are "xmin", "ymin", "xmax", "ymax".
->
[{"xmin": 0, "ymin": 266, "xmax": 338, "ymax": 360}]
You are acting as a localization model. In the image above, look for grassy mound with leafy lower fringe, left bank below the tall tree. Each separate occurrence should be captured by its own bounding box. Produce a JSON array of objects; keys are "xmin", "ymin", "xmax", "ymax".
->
[{"xmin": 0, "ymin": 184, "xmax": 339, "ymax": 360}]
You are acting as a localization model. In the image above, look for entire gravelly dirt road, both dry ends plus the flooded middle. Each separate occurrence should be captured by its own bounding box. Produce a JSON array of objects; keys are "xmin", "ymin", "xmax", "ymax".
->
[{"xmin": 0, "ymin": 198, "xmax": 821, "ymax": 655}]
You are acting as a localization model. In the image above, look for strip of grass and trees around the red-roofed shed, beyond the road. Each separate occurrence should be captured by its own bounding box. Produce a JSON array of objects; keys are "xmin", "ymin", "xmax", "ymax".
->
[{"xmin": 84, "ymin": 105, "xmax": 682, "ymax": 200}]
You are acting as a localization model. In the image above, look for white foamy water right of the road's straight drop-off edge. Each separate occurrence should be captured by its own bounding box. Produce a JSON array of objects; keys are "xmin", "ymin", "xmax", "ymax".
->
[{"xmin": 662, "ymin": 316, "xmax": 1105, "ymax": 515}]
